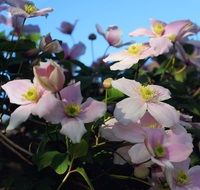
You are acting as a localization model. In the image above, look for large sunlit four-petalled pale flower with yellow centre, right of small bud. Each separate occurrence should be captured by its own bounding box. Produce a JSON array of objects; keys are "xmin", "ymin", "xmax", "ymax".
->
[{"xmin": 112, "ymin": 78, "xmax": 179, "ymax": 127}]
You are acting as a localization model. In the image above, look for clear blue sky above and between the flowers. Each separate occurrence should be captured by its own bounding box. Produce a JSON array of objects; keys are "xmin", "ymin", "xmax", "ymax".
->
[{"xmin": 5, "ymin": 0, "xmax": 200, "ymax": 65}]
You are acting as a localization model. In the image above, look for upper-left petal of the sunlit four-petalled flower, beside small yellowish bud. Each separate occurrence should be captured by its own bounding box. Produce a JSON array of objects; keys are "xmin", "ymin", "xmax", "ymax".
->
[{"xmin": 112, "ymin": 77, "xmax": 141, "ymax": 97}]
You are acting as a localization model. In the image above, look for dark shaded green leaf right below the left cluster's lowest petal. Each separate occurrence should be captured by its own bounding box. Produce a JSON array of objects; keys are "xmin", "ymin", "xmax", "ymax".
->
[{"xmin": 69, "ymin": 139, "xmax": 88, "ymax": 159}]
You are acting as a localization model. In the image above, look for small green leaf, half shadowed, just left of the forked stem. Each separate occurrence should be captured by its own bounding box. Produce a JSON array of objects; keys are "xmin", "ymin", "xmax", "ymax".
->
[{"xmin": 51, "ymin": 153, "xmax": 70, "ymax": 174}]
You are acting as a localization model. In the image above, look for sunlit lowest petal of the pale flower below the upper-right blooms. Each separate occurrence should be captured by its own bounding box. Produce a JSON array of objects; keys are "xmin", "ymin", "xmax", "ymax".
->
[{"xmin": 110, "ymin": 56, "xmax": 139, "ymax": 71}]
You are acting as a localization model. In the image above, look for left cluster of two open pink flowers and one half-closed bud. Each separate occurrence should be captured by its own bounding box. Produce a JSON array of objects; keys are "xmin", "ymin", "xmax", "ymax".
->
[{"xmin": 2, "ymin": 60, "xmax": 106, "ymax": 143}]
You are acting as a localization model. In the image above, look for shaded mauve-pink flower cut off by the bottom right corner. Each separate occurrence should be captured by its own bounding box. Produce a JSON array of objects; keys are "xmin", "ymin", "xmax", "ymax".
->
[{"xmin": 170, "ymin": 159, "xmax": 200, "ymax": 190}]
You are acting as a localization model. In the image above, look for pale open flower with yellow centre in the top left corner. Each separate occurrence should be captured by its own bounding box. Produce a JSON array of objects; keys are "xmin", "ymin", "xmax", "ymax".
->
[{"xmin": 4, "ymin": 0, "xmax": 53, "ymax": 18}]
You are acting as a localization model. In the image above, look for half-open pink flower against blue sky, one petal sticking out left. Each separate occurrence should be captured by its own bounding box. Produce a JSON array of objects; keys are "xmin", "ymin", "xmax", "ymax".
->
[{"xmin": 96, "ymin": 24, "xmax": 122, "ymax": 47}]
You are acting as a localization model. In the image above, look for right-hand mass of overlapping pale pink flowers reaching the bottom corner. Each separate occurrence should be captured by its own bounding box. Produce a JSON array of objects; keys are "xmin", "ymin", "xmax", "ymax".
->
[{"xmin": 100, "ymin": 78, "xmax": 200, "ymax": 190}]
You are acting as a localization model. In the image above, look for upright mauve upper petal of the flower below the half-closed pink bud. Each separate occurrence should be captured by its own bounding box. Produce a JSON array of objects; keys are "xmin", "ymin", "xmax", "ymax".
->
[{"xmin": 60, "ymin": 82, "xmax": 83, "ymax": 104}]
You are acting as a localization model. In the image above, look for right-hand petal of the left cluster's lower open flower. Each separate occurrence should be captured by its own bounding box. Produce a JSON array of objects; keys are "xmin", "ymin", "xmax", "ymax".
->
[{"xmin": 78, "ymin": 98, "xmax": 106, "ymax": 123}]
